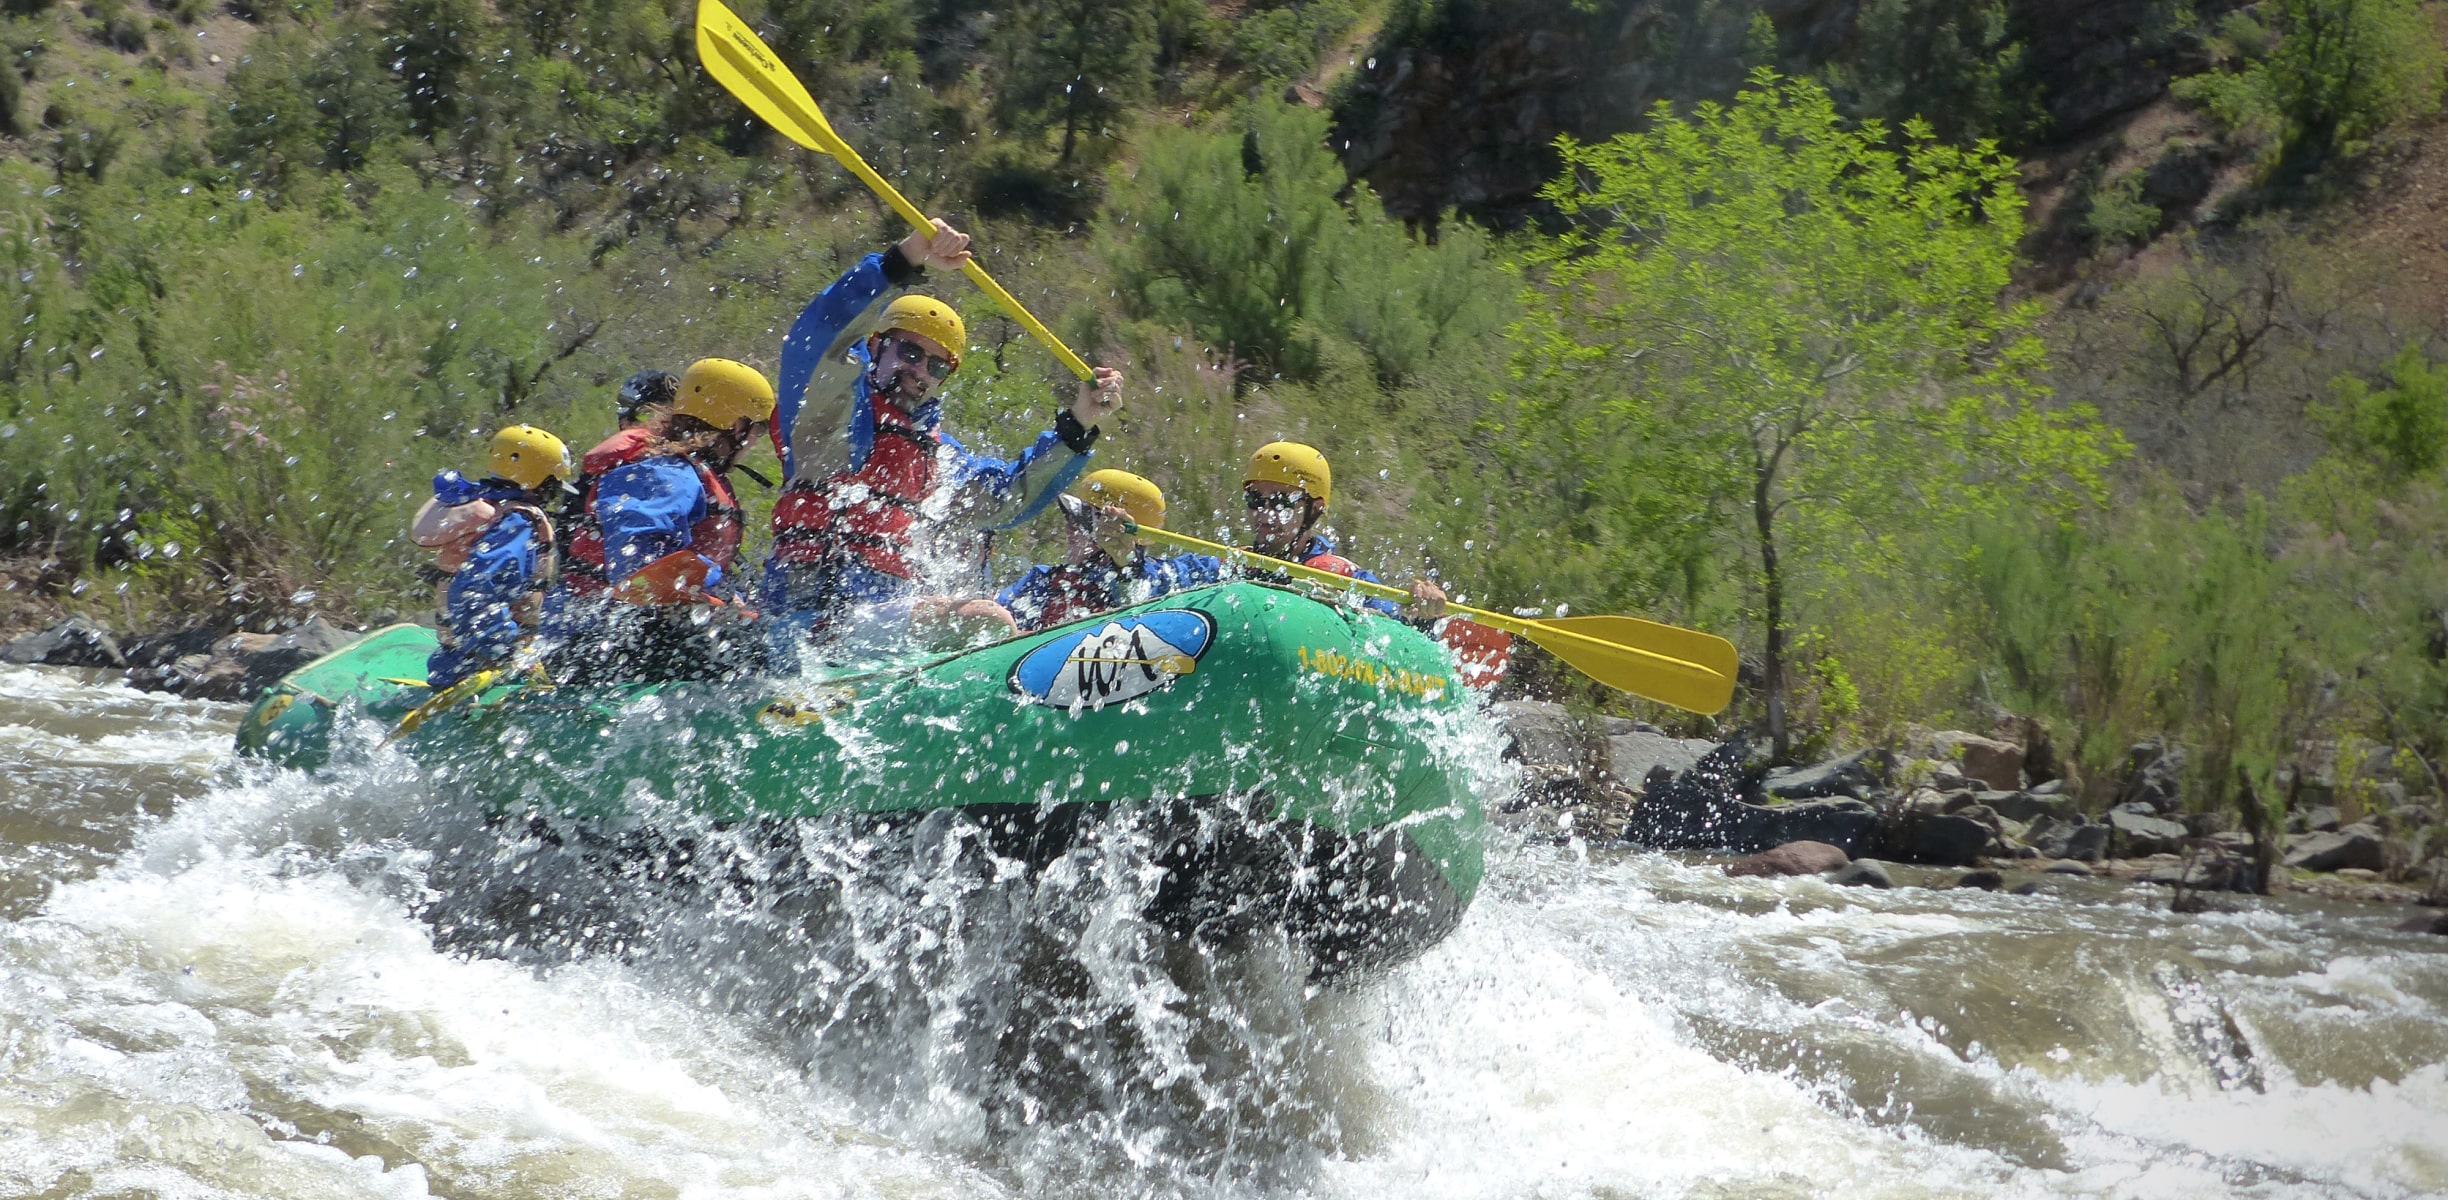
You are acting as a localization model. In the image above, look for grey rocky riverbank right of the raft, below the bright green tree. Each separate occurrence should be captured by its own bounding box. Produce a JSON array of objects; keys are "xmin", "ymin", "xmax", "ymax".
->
[{"xmin": 1496, "ymin": 700, "xmax": 2448, "ymax": 928}]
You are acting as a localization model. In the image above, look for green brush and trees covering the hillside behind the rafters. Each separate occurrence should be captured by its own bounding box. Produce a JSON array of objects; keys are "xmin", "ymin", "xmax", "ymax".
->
[{"xmin": 0, "ymin": 0, "xmax": 2448, "ymax": 857}]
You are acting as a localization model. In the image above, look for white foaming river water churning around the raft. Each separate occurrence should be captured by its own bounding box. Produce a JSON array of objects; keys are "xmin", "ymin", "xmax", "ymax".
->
[{"xmin": 0, "ymin": 669, "xmax": 2448, "ymax": 1198}]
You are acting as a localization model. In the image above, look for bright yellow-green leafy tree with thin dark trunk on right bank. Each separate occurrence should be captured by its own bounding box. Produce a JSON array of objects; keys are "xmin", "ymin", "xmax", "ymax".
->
[{"xmin": 1515, "ymin": 69, "xmax": 2118, "ymax": 757}]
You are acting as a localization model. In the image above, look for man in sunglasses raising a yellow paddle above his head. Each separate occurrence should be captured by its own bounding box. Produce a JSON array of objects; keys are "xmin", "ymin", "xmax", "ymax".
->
[{"xmin": 761, "ymin": 220, "xmax": 1121, "ymax": 656}]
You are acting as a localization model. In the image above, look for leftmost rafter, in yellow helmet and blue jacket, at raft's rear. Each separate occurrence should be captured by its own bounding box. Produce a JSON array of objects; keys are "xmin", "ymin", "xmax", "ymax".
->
[{"xmin": 426, "ymin": 426, "xmax": 573, "ymax": 688}]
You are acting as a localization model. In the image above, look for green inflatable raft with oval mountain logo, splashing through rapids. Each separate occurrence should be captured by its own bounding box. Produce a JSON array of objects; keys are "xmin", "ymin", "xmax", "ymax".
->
[{"xmin": 237, "ymin": 583, "xmax": 1483, "ymax": 975}]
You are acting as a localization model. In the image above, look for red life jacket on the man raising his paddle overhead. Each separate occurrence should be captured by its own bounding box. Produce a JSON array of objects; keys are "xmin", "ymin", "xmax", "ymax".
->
[{"xmin": 774, "ymin": 397, "xmax": 938, "ymax": 578}]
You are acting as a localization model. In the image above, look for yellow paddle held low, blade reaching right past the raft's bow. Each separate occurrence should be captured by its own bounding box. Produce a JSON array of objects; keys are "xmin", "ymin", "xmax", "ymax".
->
[{"xmin": 1131, "ymin": 524, "xmax": 1741, "ymax": 715}]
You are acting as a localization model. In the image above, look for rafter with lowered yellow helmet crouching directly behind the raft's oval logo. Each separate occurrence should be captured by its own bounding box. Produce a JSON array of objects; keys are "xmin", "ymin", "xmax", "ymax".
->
[{"xmin": 994, "ymin": 468, "xmax": 1224, "ymax": 632}]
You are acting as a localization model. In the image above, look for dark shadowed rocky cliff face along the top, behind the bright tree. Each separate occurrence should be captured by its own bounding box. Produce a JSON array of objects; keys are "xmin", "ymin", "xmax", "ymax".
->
[{"xmin": 1337, "ymin": 0, "xmax": 2233, "ymax": 228}]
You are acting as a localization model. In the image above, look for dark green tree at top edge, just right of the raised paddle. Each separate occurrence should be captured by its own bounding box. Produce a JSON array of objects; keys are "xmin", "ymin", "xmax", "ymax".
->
[{"xmin": 994, "ymin": 0, "xmax": 1155, "ymax": 167}]
